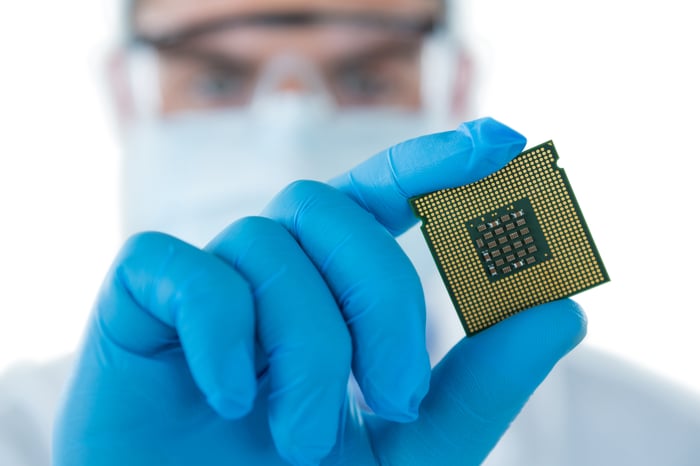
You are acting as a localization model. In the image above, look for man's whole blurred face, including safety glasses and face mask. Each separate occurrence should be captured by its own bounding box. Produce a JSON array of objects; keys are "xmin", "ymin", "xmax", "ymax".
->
[{"xmin": 117, "ymin": 0, "xmax": 455, "ymax": 245}]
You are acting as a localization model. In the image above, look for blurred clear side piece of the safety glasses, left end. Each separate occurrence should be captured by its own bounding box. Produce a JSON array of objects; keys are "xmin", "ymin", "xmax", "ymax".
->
[{"xmin": 126, "ymin": 45, "xmax": 162, "ymax": 122}]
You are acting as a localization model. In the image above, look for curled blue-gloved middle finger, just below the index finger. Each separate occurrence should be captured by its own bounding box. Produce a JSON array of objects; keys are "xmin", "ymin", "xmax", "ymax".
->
[{"xmin": 265, "ymin": 181, "xmax": 430, "ymax": 421}]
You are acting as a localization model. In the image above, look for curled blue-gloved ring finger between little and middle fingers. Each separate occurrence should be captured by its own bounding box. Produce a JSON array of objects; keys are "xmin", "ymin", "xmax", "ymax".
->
[{"xmin": 207, "ymin": 217, "xmax": 351, "ymax": 464}]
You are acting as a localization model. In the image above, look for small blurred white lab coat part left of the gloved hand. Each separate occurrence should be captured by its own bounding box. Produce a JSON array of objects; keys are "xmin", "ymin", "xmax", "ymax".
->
[{"xmin": 0, "ymin": 358, "xmax": 71, "ymax": 466}]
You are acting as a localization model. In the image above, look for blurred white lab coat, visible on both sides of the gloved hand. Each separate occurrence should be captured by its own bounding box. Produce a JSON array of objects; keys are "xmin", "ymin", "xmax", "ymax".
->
[{"xmin": 0, "ymin": 346, "xmax": 700, "ymax": 466}]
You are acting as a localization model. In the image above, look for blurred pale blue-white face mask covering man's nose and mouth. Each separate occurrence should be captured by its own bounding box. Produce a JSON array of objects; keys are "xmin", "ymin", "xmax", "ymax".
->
[{"xmin": 122, "ymin": 93, "xmax": 448, "ymax": 246}]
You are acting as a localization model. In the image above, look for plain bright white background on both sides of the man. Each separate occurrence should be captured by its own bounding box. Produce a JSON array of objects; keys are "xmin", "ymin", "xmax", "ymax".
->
[{"xmin": 0, "ymin": 0, "xmax": 700, "ymax": 393}]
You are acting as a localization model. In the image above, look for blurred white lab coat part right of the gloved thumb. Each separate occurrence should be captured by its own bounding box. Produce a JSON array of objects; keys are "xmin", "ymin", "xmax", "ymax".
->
[{"xmin": 484, "ymin": 345, "xmax": 700, "ymax": 466}]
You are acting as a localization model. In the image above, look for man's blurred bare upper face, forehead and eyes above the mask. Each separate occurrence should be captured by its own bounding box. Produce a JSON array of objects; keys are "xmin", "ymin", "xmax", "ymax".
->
[{"xmin": 134, "ymin": 0, "xmax": 440, "ymax": 116}]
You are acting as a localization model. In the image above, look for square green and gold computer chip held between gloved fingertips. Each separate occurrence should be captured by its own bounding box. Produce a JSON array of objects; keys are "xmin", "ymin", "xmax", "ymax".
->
[{"xmin": 410, "ymin": 141, "xmax": 610, "ymax": 335}]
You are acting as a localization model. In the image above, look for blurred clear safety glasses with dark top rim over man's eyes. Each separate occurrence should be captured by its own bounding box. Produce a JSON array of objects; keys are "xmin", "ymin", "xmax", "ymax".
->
[{"xmin": 128, "ymin": 13, "xmax": 457, "ymax": 117}]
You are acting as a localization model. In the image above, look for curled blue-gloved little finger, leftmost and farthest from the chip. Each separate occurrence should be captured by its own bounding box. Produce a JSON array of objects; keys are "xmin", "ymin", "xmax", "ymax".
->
[{"xmin": 96, "ymin": 233, "xmax": 256, "ymax": 418}]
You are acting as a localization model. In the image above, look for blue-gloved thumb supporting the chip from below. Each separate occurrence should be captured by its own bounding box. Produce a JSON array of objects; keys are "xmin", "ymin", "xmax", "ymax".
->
[{"xmin": 368, "ymin": 300, "xmax": 586, "ymax": 465}]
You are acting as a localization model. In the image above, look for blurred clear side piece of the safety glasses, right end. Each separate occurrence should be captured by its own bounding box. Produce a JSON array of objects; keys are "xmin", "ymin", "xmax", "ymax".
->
[{"xmin": 421, "ymin": 32, "xmax": 460, "ymax": 129}]
